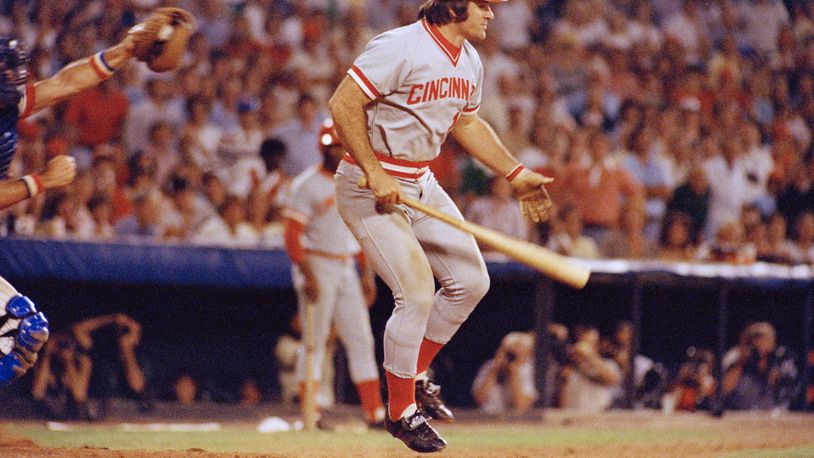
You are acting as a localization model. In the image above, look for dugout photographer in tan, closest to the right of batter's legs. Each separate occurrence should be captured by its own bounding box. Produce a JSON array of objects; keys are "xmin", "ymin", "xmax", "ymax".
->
[{"xmin": 472, "ymin": 332, "xmax": 538, "ymax": 413}]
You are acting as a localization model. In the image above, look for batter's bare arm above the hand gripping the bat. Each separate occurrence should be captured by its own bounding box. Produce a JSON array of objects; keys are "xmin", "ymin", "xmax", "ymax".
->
[{"xmin": 328, "ymin": 76, "xmax": 384, "ymax": 175}]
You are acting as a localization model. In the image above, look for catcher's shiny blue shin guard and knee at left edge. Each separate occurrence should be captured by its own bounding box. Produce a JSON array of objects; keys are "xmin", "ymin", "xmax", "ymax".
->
[{"xmin": 0, "ymin": 294, "xmax": 49, "ymax": 388}]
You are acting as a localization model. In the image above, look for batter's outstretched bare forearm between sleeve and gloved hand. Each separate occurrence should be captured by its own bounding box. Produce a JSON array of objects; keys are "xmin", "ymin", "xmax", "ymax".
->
[{"xmin": 450, "ymin": 116, "xmax": 520, "ymax": 176}]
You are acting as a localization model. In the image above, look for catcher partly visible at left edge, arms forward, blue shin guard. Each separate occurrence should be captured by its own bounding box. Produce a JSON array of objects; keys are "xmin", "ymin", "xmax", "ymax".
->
[{"xmin": 0, "ymin": 36, "xmax": 139, "ymax": 388}]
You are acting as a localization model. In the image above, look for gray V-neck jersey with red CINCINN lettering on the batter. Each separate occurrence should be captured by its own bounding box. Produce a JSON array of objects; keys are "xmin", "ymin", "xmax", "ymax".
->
[{"xmin": 348, "ymin": 20, "xmax": 483, "ymax": 161}]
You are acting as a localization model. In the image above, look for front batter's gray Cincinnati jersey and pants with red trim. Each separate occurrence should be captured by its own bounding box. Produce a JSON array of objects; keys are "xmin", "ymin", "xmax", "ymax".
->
[{"xmin": 336, "ymin": 20, "xmax": 489, "ymax": 378}]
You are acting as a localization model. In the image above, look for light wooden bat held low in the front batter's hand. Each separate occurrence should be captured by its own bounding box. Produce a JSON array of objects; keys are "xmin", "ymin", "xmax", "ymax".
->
[{"xmin": 402, "ymin": 198, "xmax": 591, "ymax": 289}]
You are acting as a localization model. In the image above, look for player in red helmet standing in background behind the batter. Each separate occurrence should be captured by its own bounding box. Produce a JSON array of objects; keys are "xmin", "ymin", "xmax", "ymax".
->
[{"xmin": 283, "ymin": 119, "xmax": 385, "ymax": 427}]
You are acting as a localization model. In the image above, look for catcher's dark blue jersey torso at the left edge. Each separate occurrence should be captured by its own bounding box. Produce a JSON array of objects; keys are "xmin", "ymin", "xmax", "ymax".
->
[{"xmin": 0, "ymin": 37, "xmax": 28, "ymax": 180}]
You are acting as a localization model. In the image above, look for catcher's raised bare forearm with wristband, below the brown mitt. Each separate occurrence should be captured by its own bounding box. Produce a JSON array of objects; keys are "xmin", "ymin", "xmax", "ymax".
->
[{"xmin": 33, "ymin": 39, "xmax": 133, "ymax": 111}]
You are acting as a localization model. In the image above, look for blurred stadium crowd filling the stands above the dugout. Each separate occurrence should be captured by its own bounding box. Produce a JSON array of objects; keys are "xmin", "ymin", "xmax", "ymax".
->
[{"xmin": 0, "ymin": 0, "xmax": 814, "ymax": 263}]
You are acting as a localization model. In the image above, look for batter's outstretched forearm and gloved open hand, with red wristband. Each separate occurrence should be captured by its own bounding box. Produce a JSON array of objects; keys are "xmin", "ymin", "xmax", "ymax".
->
[{"xmin": 450, "ymin": 115, "xmax": 554, "ymax": 223}]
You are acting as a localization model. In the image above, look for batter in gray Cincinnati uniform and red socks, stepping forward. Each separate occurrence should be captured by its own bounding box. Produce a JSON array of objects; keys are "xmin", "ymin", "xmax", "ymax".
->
[{"xmin": 329, "ymin": 0, "xmax": 552, "ymax": 452}]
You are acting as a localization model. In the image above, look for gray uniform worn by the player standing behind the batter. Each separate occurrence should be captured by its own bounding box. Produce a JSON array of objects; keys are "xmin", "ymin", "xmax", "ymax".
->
[{"xmin": 284, "ymin": 165, "xmax": 379, "ymax": 383}]
